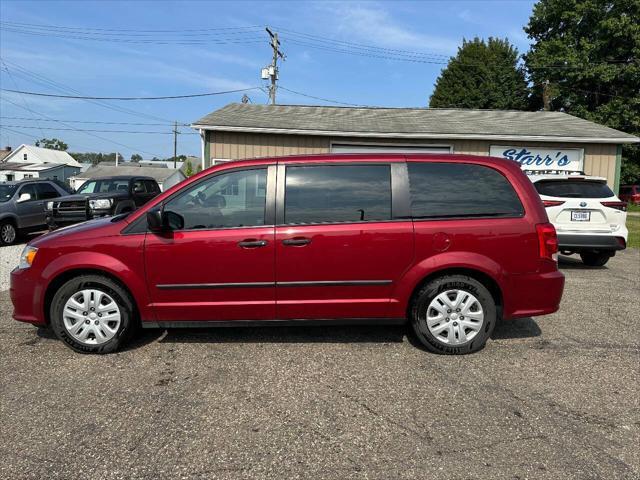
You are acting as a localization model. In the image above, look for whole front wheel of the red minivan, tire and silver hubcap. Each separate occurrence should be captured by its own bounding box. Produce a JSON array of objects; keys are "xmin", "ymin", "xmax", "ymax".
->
[{"xmin": 50, "ymin": 275, "xmax": 135, "ymax": 353}]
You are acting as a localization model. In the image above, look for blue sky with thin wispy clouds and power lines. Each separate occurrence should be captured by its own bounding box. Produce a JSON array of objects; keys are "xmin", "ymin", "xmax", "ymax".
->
[{"xmin": 0, "ymin": 0, "xmax": 534, "ymax": 159}]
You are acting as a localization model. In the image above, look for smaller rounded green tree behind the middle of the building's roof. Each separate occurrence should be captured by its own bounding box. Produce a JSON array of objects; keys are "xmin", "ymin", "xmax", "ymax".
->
[{"xmin": 429, "ymin": 37, "xmax": 528, "ymax": 110}]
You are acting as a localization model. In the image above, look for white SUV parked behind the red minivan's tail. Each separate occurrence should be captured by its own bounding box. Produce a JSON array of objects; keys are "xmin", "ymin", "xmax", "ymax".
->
[{"xmin": 531, "ymin": 175, "xmax": 629, "ymax": 266}]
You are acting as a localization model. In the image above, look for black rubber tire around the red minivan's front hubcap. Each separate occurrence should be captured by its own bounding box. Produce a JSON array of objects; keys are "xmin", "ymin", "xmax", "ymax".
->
[{"xmin": 50, "ymin": 275, "xmax": 137, "ymax": 354}]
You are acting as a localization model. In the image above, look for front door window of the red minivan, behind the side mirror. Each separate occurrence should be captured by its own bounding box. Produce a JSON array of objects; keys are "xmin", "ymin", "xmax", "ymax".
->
[{"xmin": 164, "ymin": 168, "xmax": 267, "ymax": 230}]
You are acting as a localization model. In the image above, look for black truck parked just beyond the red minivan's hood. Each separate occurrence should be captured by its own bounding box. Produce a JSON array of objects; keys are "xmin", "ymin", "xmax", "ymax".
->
[{"xmin": 45, "ymin": 175, "xmax": 160, "ymax": 230}]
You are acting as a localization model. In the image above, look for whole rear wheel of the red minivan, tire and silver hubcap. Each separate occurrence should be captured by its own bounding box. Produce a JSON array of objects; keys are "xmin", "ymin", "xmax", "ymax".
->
[{"xmin": 411, "ymin": 275, "xmax": 497, "ymax": 355}]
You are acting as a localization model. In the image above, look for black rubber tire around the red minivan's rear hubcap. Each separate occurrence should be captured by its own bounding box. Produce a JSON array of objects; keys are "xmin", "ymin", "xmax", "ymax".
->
[{"xmin": 411, "ymin": 275, "xmax": 498, "ymax": 355}]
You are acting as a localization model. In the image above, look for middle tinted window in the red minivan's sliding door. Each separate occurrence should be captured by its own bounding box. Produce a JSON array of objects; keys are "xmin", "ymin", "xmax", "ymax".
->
[{"xmin": 284, "ymin": 165, "xmax": 391, "ymax": 223}]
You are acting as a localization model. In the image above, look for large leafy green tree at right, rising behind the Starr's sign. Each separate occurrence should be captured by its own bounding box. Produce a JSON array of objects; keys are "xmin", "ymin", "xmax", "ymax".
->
[{"xmin": 524, "ymin": 0, "xmax": 640, "ymax": 183}]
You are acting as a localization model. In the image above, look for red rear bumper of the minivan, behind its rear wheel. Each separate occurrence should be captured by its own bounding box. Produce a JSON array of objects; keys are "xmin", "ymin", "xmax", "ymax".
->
[{"xmin": 503, "ymin": 270, "xmax": 564, "ymax": 320}]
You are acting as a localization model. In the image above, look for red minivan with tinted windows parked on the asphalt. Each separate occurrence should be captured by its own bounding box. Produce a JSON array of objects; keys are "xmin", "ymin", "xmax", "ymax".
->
[{"xmin": 11, "ymin": 154, "xmax": 564, "ymax": 354}]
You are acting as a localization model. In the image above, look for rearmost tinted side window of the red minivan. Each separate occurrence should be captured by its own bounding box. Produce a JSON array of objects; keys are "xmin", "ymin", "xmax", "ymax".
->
[{"xmin": 408, "ymin": 162, "xmax": 524, "ymax": 218}]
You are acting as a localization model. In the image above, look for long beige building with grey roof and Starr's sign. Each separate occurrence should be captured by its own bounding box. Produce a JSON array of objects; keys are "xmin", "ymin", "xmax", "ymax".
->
[{"xmin": 193, "ymin": 104, "xmax": 640, "ymax": 191}]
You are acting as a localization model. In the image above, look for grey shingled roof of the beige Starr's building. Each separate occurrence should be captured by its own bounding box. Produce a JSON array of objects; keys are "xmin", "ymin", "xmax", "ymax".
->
[{"xmin": 192, "ymin": 103, "xmax": 640, "ymax": 143}]
